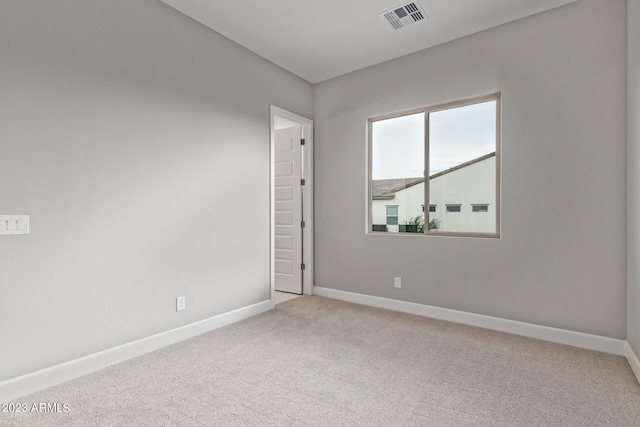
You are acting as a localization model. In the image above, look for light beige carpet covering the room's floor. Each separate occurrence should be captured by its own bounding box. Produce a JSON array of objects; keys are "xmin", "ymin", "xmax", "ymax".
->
[{"xmin": 0, "ymin": 296, "xmax": 640, "ymax": 426}]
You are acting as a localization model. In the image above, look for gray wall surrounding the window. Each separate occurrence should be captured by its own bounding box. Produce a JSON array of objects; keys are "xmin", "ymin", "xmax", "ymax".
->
[{"xmin": 314, "ymin": 0, "xmax": 627, "ymax": 339}]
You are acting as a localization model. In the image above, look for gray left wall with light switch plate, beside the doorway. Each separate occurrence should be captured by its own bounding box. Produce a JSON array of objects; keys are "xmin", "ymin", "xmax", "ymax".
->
[{"xmin": 0, "ymin": 0, "xmax": 312, "ymax": 381}]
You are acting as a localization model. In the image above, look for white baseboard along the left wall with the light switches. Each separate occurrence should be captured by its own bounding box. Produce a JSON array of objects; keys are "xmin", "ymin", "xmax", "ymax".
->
[{"xmin": 0, "ymin": 300, "xmax": 273, "ymax": 402}]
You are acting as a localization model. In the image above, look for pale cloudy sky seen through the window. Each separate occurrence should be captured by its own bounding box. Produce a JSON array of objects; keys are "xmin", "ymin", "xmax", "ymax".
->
[{"xmin": 371, "ymin": 101, "xmax": 496, "ymax": 179}]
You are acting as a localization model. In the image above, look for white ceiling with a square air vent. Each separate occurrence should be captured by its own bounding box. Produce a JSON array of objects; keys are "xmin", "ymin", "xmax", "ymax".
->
[{"xmin": 161, "ymin": 0, "xmax": 577, "ymax": 83}]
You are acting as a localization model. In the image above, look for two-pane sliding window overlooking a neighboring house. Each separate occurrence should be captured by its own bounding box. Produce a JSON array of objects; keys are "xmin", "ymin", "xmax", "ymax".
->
[{"xmin": 368, "ymin": 94, "xmax": 500, "ymax": 237}]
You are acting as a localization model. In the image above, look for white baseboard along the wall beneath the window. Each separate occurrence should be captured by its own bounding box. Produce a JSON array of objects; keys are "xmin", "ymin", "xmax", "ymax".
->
[{"xmin": 313, "ymin": 286, "xmax": 637, "ymax": 358}]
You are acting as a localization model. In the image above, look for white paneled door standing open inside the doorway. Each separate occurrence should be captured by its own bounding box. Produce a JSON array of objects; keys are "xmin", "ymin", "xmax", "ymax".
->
[{"xmin": 274, "ymin": 126, "xmax": 302, "ymax": 294}]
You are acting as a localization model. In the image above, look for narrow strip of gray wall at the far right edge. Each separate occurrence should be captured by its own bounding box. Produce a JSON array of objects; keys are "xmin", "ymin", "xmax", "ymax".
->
[{"xmin": 627, "ymin": 0, "xmax": 640, "ymax": 356}]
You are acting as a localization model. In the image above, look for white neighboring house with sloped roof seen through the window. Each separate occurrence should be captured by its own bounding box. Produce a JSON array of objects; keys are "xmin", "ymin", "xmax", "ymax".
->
[{"xmin": 371, "ymin": 152, "xmax": 497, "ymax": 233}]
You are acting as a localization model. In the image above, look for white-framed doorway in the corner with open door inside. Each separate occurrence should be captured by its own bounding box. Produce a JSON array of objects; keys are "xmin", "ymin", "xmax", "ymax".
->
[{"xmin": 270, "ymin": 105, "xmax": 313, "ymax": 301}]
